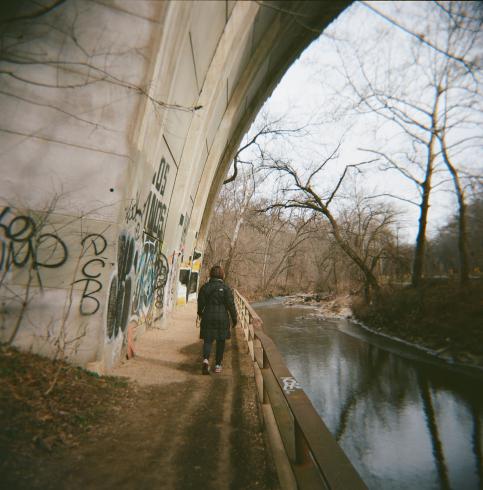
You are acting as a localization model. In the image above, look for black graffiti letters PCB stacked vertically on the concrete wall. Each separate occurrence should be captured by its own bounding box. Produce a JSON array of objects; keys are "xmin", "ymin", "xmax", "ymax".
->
[{"xmin": 74, "ymin": 233, "xmax": 107, "ymax": 316}]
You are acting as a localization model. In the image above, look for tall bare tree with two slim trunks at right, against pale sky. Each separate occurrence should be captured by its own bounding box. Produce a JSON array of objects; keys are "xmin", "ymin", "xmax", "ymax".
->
[{"xmin": 339, "ymin": 2, "xmax": 482, "ymax": 286}]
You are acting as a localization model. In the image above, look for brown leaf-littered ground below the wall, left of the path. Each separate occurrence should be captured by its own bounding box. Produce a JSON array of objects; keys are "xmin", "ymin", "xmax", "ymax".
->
[{"xmin": 0, "ymin": 346, "xmax": 134, "ymax": 463}]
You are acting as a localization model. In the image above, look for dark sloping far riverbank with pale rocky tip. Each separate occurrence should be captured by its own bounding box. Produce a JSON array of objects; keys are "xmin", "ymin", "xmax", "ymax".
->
[{"xmin": 284, "ymin": 281, "xmax": 483, "ymax": 367}]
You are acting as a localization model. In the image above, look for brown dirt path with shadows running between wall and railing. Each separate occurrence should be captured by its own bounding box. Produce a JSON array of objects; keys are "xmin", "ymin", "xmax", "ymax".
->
[{"xmin": 18, "ymin": 304, "xmax": 278, "ymax": 490}]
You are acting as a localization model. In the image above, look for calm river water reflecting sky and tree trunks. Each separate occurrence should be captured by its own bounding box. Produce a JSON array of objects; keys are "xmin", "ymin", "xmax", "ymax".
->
[{"xmin": 255, "ymin": 304, "xmax": 483, "ymax": 490}]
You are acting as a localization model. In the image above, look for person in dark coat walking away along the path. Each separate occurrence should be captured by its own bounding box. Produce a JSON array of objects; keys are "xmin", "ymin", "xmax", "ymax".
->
[{"xmin": 198, "ymin": 265, "xmax": 237, "ymax": 374}]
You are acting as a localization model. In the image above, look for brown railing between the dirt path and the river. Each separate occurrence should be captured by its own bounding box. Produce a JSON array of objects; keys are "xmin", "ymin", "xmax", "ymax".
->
[{"xmin": 235, "ymin": 291, "xmax": 367, "ymax": 490}]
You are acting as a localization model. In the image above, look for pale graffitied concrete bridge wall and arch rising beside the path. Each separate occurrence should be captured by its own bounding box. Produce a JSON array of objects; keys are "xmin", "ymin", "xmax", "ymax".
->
[{"xmin": 0, "ymin": 0, "xmax": 347, "ymax": 367}]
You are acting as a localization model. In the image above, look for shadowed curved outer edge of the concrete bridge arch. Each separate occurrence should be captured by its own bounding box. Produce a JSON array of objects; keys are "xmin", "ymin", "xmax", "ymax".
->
[{"xmin": 193, "ymin": 2, "xmax": 351, "ymax": 248}]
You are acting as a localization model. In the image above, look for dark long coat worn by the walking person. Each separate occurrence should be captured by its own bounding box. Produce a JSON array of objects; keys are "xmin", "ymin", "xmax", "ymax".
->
[{"xmin": 198, "ymin": 278, "xmax": 237, "ymax": 340}]
